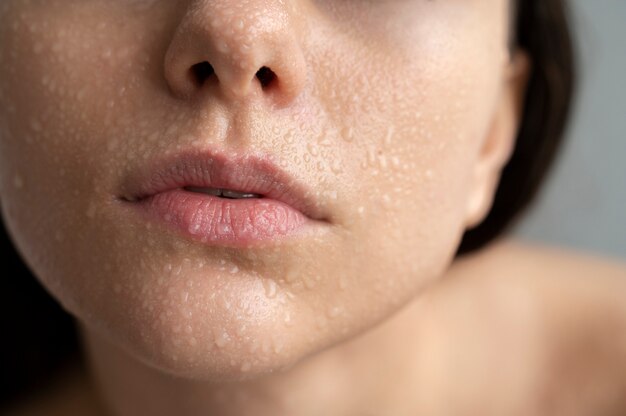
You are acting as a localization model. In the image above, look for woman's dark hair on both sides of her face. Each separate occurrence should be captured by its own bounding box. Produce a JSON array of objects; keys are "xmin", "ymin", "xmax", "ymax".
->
[{"xmin": 0, "ymin": 0, "xmax": 575, "ymax": 407}]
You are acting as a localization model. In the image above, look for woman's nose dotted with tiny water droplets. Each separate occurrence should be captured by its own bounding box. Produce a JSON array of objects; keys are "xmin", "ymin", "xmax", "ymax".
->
[{"xmin": 164, "ymin": 0, "xmax": 307, "ymax": 105}]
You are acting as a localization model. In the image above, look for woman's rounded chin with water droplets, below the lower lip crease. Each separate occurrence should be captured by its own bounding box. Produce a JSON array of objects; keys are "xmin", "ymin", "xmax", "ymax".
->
[{"xmin": 75, "ymin": 270, "xmax": 347, "ymax": 382}]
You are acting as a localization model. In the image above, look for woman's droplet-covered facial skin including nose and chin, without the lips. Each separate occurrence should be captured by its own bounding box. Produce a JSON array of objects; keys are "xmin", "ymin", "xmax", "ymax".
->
[{"xmin": 0, "ymin": 0, "xmax": 515, "ymax": 379}]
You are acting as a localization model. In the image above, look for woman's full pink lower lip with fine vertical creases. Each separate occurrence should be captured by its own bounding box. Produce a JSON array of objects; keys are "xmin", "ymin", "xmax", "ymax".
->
[{"xmin": 131, "ymin": 188, "xmax": 312, "ymax": 247}]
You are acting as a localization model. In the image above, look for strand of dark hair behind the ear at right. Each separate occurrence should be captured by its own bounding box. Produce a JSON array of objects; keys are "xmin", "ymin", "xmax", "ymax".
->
[{"xmin": 456, "ymin": 0, "xmax": 576, "ymax": 257}]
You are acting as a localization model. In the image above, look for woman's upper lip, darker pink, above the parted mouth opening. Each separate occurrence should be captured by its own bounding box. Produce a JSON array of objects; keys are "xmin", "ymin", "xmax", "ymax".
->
[{"xmin": 122, "ymin": 150, "xmax": 326, "ymax": 220}]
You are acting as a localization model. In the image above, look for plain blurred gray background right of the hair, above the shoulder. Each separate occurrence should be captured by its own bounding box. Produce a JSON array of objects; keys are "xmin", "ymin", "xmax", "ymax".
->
[{"xmin": 514, "ymin": 0, "xmax": 626, "ymax": 260}]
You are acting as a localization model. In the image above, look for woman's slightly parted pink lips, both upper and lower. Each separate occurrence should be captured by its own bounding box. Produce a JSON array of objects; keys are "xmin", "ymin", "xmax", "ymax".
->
[{"xmin": 120, "ymin": 151, "xmax": 327, "ymax": 246}]
